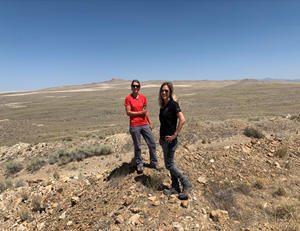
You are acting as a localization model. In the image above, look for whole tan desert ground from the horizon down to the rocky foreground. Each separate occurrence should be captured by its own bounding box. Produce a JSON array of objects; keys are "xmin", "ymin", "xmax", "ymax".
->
[{"xmin": 0, "ymin": 79, "xmax": 300, "ymax": 230}]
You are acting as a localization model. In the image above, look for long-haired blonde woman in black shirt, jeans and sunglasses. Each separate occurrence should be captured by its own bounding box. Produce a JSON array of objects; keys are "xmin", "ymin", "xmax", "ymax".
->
[{"xmin": 158, "ymin": 82, "xmax": 194, "ymax": 198}]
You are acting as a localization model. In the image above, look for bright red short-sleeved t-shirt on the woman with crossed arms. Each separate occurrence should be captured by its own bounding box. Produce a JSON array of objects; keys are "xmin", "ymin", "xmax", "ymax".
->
[{"xmin": 124, "ymin": 94, "xmax": 148, "ymax": 126}]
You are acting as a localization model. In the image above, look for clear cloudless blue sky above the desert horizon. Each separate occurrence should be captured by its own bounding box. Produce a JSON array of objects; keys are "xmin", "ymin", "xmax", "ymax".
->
[{"xmin": 0, "ymin": 0, "xmax": 300, "ymax": 91}]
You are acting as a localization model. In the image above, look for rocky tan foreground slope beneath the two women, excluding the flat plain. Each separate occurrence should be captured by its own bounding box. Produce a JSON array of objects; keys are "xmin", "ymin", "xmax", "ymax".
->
[{"xmin": 0, "ymin": 117, "xmax": 300, "ymax": 231}]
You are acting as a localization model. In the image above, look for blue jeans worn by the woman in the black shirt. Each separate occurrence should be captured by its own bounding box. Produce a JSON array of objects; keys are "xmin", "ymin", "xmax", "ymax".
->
[{"xmin": 161, "ymin": 138, "xmax": 187, "ymax": 188}]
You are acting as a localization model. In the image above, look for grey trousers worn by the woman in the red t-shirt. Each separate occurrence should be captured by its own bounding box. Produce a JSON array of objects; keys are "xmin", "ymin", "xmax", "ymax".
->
[{"xmin": 129, "ymin": 124, "xmax": 158, "ymax": 167}]
